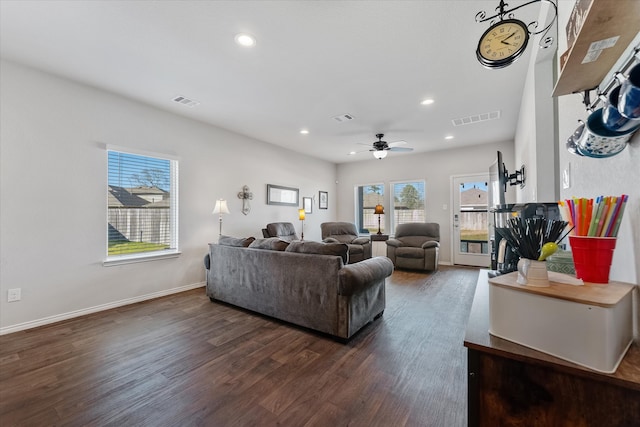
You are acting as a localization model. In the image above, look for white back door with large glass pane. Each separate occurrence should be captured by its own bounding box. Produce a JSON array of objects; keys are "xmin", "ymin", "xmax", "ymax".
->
[{"xmin": 451, "ymin": 173, "xmax": 491, "ymax": 268}]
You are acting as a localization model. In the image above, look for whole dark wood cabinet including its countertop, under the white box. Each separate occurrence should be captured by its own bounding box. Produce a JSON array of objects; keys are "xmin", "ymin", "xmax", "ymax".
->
[{"xmin": 465, "ymin": 272, "xmax": 640, "ymax": 427}]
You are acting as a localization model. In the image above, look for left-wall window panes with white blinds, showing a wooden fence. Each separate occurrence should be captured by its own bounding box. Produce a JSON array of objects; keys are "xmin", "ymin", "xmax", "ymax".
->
[{"xmin": 107, "ymin": 149, "xmax": 178, "ymax": 262}]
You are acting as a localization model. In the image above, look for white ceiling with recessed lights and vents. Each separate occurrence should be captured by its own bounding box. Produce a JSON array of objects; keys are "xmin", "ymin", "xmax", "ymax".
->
[{"xmin": 0, "ymin": 0, "xmax": 552, "ymax": 163}]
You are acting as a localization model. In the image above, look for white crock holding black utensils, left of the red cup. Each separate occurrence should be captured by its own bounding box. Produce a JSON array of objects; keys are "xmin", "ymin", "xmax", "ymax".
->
[{"xmin": 496, "ymin": 217, "xmax": 571, "ymax": 287}]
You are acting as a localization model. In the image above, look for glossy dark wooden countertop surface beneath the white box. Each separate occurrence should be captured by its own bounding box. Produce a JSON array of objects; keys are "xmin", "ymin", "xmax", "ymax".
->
[{"xmin": 464, "ymin": 270, "xmax": 640, "ymax": 390}]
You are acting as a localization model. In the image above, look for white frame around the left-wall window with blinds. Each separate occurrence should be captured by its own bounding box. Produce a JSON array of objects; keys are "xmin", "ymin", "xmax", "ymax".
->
[{"xmin": 102, "ymin": 145, "xmax": 181, "ymax": 267}]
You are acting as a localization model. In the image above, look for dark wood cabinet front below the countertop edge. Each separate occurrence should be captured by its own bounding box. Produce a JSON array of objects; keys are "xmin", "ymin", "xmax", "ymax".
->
[{"xmin": 468, "ymin": 350, "xmax": 640, "ymax": 427}]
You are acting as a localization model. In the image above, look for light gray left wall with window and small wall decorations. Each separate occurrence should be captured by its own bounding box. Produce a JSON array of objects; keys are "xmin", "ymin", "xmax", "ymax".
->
[{"xmin": 0, "ymin": 61, "xmax": 336, "ymax": 333}]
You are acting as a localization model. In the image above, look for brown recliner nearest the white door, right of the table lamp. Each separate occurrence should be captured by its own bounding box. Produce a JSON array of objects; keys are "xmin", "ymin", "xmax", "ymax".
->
[{"xmin": 387, "ymin": 222, "xmax": 440, "ymax": 270}]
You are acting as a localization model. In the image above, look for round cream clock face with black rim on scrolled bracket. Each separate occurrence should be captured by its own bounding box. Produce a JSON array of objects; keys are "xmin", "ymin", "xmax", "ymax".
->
[{"xmin": 476, "ymin": 19, "xmax": 529, "ymax": 68}]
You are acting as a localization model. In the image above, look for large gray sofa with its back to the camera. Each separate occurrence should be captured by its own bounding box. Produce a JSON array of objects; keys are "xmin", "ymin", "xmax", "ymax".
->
[{"xmin": 205, "ymin": 238, "xmax": 393, "ymax": 340}]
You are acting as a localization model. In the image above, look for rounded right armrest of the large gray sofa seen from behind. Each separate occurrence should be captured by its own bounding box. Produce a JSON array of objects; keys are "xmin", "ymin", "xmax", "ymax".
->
[{"xmin": 338, "ymin": 257, "xmax": 393, "ymax": 296}]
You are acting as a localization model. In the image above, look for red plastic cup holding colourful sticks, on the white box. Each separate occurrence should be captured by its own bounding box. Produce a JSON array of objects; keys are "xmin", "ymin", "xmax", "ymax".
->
[{"xmin": 569, "ymin": 236, "xmax": 616, "ymax": 284}]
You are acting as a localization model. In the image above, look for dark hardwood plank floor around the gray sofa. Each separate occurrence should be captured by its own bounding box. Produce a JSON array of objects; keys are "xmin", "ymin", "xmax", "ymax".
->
[{"xmin": 0, "ymin": 266, "xmax": 478, "ymax": 427}]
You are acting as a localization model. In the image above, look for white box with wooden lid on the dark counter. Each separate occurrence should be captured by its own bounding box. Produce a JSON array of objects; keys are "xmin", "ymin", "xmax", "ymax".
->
[{"xmin": 489, "ymin": 273, "xmax": 634, "ymax": 373}]
